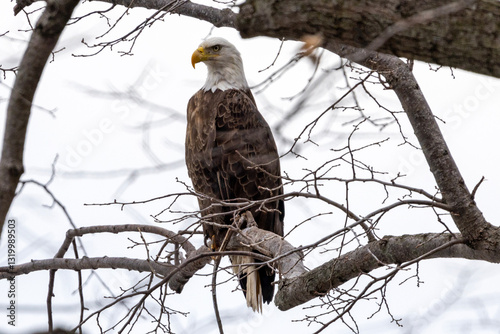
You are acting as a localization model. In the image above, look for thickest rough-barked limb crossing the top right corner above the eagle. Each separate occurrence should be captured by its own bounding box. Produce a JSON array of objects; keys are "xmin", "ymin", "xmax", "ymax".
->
[{"xmin": 236, "ymin": 0, "xmax": 500, "ymax": 77}]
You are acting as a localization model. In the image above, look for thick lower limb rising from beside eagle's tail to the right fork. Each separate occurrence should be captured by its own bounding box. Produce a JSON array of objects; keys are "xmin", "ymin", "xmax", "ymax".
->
[{"xmin": 275, "ymin": 233, "xmax": 474, "ymax": 311}]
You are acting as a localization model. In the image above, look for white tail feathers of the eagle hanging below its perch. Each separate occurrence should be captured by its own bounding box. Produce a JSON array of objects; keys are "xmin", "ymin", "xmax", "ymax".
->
[{"xmin": 230, "ymin": 256, "xmax": 262, "ymax": 313}]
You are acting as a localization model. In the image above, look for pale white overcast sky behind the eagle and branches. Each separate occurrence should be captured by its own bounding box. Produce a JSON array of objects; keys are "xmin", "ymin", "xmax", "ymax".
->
[{"xmin": 0, "ymin": 2, "xmax": 500, "ymax": 334}]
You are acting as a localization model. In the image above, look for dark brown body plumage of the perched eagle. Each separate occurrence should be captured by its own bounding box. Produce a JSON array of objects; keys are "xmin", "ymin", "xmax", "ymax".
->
[{"xmin": 186, "ymin": 89, "xmax": 284, "ymax": 310}]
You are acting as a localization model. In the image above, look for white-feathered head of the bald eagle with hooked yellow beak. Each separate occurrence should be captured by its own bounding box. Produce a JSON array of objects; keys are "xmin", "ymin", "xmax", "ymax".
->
[{"xmin": 191, "ymin": 37, "xmax": 248, "ymax": 92}]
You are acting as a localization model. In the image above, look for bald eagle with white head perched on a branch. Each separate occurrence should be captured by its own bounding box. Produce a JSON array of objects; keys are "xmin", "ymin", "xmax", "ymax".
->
[{"xmin": 186, "ymin": 37, "xmax": 285, "ymax": 312}]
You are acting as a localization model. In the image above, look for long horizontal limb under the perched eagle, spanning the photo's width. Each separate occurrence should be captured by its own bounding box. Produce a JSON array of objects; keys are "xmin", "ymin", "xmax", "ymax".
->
[{"xmin": 0, "ymin": 225, "xmax": 500, "ymax": 310}]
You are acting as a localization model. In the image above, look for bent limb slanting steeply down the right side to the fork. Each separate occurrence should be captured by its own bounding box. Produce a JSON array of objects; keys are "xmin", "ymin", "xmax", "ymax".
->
[{"xmin": 325, "ymin": 42, "xmax": 500, "ymax": 250}]
